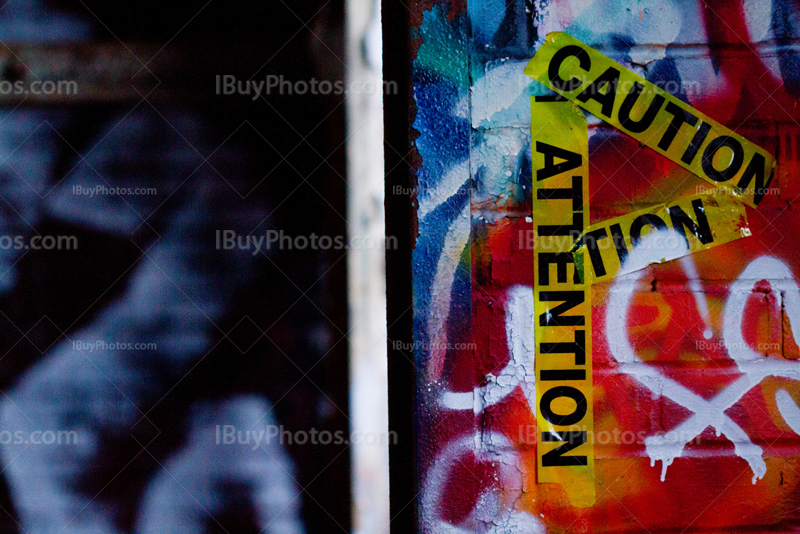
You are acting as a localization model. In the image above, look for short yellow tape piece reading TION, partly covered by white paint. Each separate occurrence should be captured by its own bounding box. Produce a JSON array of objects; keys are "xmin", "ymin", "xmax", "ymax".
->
[{"xmin": 574, "ymin": 189, "xmax": 751, "ymax": 284}]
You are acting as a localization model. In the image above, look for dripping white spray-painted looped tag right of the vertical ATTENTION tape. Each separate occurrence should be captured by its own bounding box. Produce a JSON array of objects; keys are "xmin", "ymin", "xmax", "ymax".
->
[{"xmin": 606, "ymin": 230, "xmax": 800, "ymax": 484}]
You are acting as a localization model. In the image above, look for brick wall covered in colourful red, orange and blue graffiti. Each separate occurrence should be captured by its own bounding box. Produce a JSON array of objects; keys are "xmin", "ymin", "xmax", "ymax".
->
[{"xmin": 410, "ymin": 0, "xmax": 800, "ymax": 534}]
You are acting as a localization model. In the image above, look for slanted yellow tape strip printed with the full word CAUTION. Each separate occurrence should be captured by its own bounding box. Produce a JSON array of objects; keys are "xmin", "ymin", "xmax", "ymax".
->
[{"xmin": 525, "ymin": 32, "xmax": 775, "ymax": 207}]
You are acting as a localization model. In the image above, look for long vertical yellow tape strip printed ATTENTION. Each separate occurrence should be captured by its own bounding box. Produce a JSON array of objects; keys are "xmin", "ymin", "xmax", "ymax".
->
[{"xmin": 531, "ymin": 97, "xmax": 595, "ymax": 508}]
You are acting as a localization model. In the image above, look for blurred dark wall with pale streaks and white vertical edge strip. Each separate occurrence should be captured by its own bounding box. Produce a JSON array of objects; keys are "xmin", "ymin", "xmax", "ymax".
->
[{"xmin": 0, "ymin": 0, "xmax": 388, "ymax": 533}]
